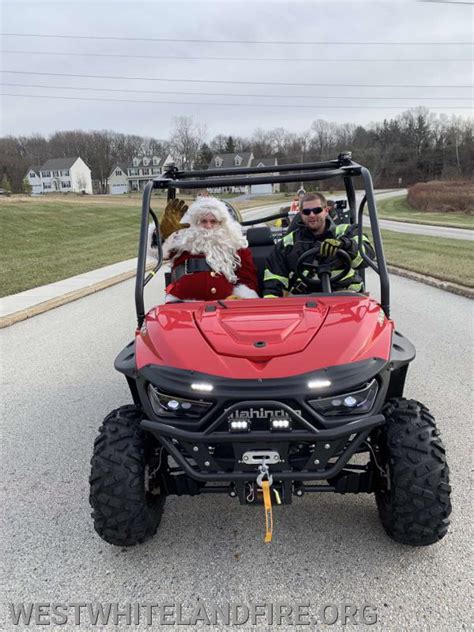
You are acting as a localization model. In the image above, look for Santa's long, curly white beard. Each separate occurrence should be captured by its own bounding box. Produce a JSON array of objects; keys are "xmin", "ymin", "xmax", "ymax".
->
[{"xmin": 163, "ymin": 227, "xmax": 247, "ymax": 283}]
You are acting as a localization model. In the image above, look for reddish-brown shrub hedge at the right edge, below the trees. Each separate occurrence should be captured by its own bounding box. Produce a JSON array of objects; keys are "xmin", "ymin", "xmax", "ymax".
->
[{"xmin": 407, "ymin": 181, "xmax": 474, "ymax": 215}]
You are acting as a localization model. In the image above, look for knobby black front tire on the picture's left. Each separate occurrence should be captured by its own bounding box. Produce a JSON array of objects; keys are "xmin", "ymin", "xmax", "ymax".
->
[{"xmin": 89, "ymin": 406, "xmax": 165, "ymax": 546}]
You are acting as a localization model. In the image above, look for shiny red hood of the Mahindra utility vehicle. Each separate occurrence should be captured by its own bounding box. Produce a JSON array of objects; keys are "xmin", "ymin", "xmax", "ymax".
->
[{"xmin": 136, "ymin": 294, "xmax": 393, "ymax": 379}]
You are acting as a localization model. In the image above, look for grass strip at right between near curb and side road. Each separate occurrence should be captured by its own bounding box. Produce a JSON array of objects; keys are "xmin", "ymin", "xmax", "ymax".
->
[{"xmin": 382, "ymin": 230, "xmax": 474, "ymax": 287}]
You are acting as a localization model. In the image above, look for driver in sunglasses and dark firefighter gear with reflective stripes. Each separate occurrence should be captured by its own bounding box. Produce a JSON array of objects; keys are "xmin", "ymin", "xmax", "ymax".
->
[{"xmin": 263, "ymin": 193, "xmax": 374, "ymax": 298}]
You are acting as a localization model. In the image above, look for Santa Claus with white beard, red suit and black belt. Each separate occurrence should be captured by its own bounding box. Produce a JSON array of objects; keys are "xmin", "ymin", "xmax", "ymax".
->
[{"xmin": 149, "ymin": 197, "xmax": 258, "ymax": 302}]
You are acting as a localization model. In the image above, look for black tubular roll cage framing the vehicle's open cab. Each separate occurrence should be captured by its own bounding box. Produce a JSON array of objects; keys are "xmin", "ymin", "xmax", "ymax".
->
[{"xmin": 135, "ymin": 152, "xmax": 390, "ymax": 327}]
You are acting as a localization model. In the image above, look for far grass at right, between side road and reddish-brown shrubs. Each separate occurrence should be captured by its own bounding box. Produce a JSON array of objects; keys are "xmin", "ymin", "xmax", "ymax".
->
[{"xmin": 377, "ymin": 195, "xmax": 474, "ymax": 230}]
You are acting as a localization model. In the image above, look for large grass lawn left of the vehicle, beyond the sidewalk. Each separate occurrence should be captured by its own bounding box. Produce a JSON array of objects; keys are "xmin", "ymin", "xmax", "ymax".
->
[{"xmin": 0, "ymin": 200, "xmax": 146, "ymax": 296}]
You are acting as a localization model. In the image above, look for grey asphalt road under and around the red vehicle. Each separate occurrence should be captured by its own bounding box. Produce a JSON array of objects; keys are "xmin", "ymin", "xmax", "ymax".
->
[{"xmin": 0, "ymin": 277, "xmax": 473, "ymax": 631}]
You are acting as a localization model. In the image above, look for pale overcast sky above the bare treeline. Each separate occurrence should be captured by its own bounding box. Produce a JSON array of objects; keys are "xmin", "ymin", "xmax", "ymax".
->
[{"xmin": 0, "ymin": 0, "xmax": 474, "ymax": 138}]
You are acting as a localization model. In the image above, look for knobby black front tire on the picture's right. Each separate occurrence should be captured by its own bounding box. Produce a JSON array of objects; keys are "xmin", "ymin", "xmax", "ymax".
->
[{"xmin": 374, "ymin": 398, "xmax": 451, "ymax": 546}]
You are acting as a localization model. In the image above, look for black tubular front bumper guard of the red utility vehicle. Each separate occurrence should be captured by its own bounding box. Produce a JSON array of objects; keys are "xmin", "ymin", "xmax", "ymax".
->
[{"xmin": 141, "ymin": 400, "xmax": 385, "ymax": 483}]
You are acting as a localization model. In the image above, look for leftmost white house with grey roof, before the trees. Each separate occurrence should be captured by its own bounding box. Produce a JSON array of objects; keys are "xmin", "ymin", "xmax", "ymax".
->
[{"xmin": 26, "ymin": 156, "xmax": 92, "ymax": 194}]
